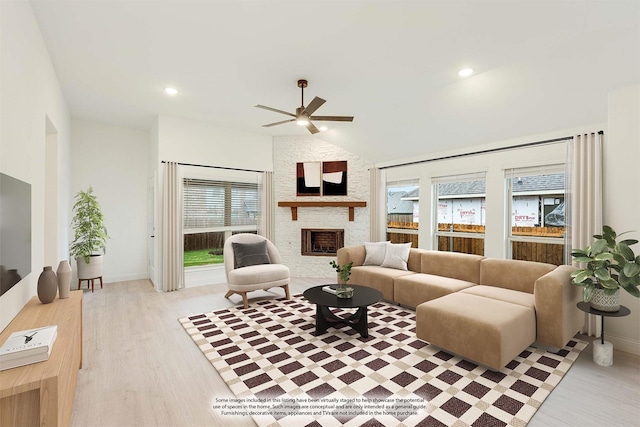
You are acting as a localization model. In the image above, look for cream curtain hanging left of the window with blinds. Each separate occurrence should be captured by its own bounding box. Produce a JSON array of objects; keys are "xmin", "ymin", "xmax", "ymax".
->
[{"xmin": 162, "ymin": 162, "xmax": 184, "ymax": 292}]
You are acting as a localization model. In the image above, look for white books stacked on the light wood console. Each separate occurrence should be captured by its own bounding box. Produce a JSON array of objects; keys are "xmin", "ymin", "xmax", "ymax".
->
[{"xmin": 0, "ymin": 325, "xmax": 58, "ymax": 365}]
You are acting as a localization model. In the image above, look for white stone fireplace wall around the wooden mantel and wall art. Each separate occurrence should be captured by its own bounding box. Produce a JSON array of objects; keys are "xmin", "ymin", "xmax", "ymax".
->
[{"xmin": 273, "ymin": 136, "xmax": 373, "ymax": 277}]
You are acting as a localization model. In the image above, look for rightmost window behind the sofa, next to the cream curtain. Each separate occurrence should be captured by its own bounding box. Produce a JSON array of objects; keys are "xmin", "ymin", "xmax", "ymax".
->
[{"xmin": 505, "ymin": 165, "xmax": 565, "ymax": 265}]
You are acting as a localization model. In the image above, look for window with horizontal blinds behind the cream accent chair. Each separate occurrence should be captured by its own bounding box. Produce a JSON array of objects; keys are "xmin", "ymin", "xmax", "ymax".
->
[{"xmin": 183, "ymin": 178, "xmax": 259, "ymax": 267}]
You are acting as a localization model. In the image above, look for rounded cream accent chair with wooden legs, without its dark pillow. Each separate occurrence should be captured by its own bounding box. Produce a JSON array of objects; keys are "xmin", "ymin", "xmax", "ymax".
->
[{"xmin": 223, "ymin": 233, "xmax": 291, "ymax": 308}]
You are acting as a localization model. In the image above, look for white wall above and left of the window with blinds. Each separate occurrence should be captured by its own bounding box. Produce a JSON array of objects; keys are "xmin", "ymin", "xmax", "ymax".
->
[{"xmin": 155, "ymin": 116, "xmax": 273, "ymax": 290}]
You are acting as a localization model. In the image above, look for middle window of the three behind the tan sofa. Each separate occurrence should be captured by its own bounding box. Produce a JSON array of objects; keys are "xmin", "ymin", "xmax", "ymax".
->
[{"xmin": 433, "ymin": 173, "xmax": 486, "ymax": 255}]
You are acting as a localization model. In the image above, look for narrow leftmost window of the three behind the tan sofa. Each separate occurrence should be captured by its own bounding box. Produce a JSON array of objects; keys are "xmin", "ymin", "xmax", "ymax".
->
[{"xmin": 387, "ymin": 180, "xmax": 420, "ymax": 248}]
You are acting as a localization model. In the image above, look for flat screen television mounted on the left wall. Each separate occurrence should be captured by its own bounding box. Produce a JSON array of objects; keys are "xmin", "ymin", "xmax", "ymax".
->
[{"xmin": 0, "ymin": 173, "xmax": 31, "ymax": 296}]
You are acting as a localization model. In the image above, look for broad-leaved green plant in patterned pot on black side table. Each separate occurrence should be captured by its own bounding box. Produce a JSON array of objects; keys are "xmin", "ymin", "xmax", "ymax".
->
[{"xmin": 571, "ymin": 225, "xmax": 640, "ymax": 312}]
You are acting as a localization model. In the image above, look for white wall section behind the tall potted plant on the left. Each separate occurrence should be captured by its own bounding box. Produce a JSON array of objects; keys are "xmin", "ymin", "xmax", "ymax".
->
[{"xmin": 69, "ymin": 119, "xmax": 150, "ymax": 282}]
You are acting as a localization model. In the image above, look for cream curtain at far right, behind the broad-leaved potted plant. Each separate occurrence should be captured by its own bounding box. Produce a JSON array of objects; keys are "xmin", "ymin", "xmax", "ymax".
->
[{"xmin": 565, "ymin": 133, "xmax": 602, "ymax": 337}]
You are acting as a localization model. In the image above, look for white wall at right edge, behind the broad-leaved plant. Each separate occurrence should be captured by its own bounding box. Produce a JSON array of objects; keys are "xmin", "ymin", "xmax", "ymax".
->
[{"xmin": 603, "ymin": 85, "xmax": 640, "ymax": 354}]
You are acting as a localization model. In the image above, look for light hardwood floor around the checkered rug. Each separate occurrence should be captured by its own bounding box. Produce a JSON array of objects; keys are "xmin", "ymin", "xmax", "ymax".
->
[{"xmin": 71, "ymin": 278, "xmax": 640, "ymax": 427}]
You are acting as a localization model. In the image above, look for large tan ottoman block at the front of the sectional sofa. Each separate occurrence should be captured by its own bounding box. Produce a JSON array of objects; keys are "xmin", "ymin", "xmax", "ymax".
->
[{"xmin": 416, "ymin": 293, "xmax": 536, "ymax": 370}]
